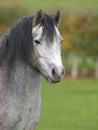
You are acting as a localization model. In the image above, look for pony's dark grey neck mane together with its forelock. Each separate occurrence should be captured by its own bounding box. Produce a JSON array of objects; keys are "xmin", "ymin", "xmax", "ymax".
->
[{"xmin": 0, "ymin": 14, "xmax": 55, "ymax": 66}]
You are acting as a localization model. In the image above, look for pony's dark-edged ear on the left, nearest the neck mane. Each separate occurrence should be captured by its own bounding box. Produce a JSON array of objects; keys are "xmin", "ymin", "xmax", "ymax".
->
[{"xmin": 33, "ymin": 10, "xmax": 42, "ymax": 26}]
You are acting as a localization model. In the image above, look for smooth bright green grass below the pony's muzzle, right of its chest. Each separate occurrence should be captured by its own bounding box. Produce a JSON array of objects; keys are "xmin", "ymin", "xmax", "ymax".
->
[{"xmin": 37, "ymin": 79, "xmax": 98, "ymax": 130}]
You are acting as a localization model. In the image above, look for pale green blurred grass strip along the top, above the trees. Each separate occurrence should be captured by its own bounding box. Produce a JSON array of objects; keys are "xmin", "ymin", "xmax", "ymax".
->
[{"xmin": 0, "ymin": 0, "xmax": 98, "ymax": 10}]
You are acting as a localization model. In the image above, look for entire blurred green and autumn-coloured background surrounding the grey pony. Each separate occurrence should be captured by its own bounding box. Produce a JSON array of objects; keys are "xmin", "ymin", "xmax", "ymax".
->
[{"xmin": 0, "ymin": 0, "xmax": 98, "ymax": 130}]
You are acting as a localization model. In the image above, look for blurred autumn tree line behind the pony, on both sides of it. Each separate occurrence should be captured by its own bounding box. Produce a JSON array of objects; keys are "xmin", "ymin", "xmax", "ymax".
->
[{"xmin": 0, "ymin": 4, "xmax": 98, "ymax": 78}]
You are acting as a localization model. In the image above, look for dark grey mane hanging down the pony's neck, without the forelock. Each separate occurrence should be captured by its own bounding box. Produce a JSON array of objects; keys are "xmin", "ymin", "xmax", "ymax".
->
[{"xmin": 0, "ymin": 17, "xmax": 33, "ymax": 64}]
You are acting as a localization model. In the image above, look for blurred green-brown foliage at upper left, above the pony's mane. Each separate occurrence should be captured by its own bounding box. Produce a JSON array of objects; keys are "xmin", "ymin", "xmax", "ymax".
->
[{"xmin": 0, "ymin": 7, "xmax": 27, "ymax": 30}]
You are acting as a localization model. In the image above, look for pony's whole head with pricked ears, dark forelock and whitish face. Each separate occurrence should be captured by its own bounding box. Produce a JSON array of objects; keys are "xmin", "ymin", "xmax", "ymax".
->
[{"xmin": 32, "ymin": 10, "xmax": 64, "ymax": 82}]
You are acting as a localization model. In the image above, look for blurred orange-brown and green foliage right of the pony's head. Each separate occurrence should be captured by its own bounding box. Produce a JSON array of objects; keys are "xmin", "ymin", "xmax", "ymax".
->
[{"xmin": 61, "ymin": 10, "xmax": 98, "ymax": 55}]
